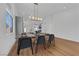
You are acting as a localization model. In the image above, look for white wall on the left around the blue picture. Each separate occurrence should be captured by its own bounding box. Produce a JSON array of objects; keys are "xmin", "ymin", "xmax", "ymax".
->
[{"xmin": 0, "ymin": 4, "xmax": 15, "ymax": 55}]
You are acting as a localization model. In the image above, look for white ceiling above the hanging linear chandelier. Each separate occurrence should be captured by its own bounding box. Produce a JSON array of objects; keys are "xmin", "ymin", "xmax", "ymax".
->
[{"xmin": 15, "ymin": 3, "xmax": 79, "ymax": 17}]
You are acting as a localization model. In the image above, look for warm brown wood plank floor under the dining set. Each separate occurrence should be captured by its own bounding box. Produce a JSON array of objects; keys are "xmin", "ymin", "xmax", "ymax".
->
[{"xmin": 8, "ymin": 38, "xmax": 79, "ymax": 56}]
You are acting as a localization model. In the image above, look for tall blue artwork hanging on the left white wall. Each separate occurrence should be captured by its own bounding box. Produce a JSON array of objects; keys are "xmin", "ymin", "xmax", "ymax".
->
[{"xmin": 5, "ymin": 11, "xmax": 13, "ymax": 33}]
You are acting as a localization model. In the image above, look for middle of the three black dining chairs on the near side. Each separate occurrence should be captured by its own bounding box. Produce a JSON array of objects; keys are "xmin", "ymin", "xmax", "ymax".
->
[{"xmin": 35, "ymin": 35, "xmax": 46, "ymax": 53}]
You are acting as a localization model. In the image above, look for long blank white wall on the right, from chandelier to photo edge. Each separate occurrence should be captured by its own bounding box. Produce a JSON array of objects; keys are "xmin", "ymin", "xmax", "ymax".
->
[{"xmin": 43, "ymin": 7, "xmax": 79, "ymax": 42}]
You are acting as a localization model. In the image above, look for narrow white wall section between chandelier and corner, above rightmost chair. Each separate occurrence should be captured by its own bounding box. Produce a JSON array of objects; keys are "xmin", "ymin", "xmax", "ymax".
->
[{"xmin": 42, "ymin": 16, "xmax": 55, "ymax": 34}]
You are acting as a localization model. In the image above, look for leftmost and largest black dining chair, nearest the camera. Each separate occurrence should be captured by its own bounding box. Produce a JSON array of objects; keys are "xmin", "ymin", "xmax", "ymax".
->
[{"xmin": 17, "ymin": 37, "xmax": 33, "ymax": 55}]
